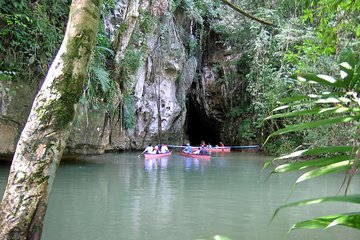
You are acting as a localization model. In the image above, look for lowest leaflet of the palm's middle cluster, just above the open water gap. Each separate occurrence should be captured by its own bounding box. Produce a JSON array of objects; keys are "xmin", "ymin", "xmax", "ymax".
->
[{"xmin": 295, "ymin": 160, "xmax": 353, "ymax": 184}]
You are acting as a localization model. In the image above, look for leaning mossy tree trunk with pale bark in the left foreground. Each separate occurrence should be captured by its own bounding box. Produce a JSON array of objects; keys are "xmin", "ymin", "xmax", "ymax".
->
[{"xmin": 0, "ymin": 0, "xmax": 102, "ymax": 240}]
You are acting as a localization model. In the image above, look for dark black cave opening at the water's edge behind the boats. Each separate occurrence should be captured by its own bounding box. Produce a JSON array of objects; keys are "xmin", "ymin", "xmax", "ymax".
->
[{"xmin": 186, "ymin": 96, "xmax": 221, "ymax": 146}]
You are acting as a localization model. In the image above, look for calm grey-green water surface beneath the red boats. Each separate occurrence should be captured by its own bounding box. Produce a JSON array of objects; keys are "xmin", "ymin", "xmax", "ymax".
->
[{"xmin": 0, "ymin": 152, "xmax": 360, "ymax": 240}]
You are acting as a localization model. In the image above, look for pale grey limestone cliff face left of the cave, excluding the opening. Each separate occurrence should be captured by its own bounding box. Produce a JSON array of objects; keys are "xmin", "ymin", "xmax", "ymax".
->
[{"xmin": 68, "ymin": 1, "xmax": 197, "ymax": 153}]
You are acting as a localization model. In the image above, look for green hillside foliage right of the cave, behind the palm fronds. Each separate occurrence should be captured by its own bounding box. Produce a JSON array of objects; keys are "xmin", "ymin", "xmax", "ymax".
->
[{"xmin": 217, "ymin": 2, "xmax": 348, "ymax": 151}]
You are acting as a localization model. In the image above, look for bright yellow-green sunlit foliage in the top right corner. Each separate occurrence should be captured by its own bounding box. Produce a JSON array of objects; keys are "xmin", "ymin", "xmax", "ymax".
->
[{"xmin": 298, "ymin": 0, "xmax": 360, "ymax": 60}]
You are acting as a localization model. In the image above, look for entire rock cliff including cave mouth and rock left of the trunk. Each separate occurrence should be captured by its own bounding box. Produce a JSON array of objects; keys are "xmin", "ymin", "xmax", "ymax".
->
[{"xmin": 0, "ymin": 0, "xmax": 245, "ymax": 154}]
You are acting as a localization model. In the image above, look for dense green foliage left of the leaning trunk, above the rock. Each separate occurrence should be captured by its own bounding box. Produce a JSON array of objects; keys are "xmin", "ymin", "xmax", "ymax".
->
[{"xmin": 0, "ymin": 0, "xmax": 69, "ymax": 81}]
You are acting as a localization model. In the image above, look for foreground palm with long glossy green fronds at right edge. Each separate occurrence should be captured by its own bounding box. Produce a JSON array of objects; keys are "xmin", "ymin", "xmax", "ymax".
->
[{"xmin": 265, "ymin": 51, "xmax": 360, "ymax": 230}]
